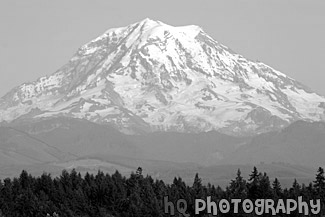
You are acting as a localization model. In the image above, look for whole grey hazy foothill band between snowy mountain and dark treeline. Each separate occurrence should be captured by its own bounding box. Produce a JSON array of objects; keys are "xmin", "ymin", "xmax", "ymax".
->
[{"xmin": 0, "ymin": 118, "xmax": 325, "ymax": 186}]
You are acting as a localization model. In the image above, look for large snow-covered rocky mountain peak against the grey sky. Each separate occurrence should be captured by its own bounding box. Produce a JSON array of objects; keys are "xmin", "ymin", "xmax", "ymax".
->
[{"xmin": 0, "ymin": 19, "xmax": 325, "ymax": 134}]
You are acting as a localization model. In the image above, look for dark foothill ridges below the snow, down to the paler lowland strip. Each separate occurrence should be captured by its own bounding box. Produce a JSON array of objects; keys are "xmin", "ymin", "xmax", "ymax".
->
[{"xmin": 0, "ymin": 118, "xmax": 325, "ymax": 170}]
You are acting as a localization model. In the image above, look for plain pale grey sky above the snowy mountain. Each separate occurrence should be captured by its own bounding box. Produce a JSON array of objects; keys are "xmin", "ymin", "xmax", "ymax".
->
[{"xmin": 0, "ymin": 0, "xmax": 325, "ymax": 96}]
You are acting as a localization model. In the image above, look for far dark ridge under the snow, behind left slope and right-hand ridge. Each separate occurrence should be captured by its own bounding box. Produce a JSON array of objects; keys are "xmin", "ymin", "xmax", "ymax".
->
[{"xmin": 0, "ymin": 118, "xmax": 249, "ymax": 165}]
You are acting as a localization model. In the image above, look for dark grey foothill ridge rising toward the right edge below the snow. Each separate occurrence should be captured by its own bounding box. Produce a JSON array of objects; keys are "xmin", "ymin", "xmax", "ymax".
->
[{"xmin": 222, "ymin": 121, "xmax": 325, "ymax": 167}]
